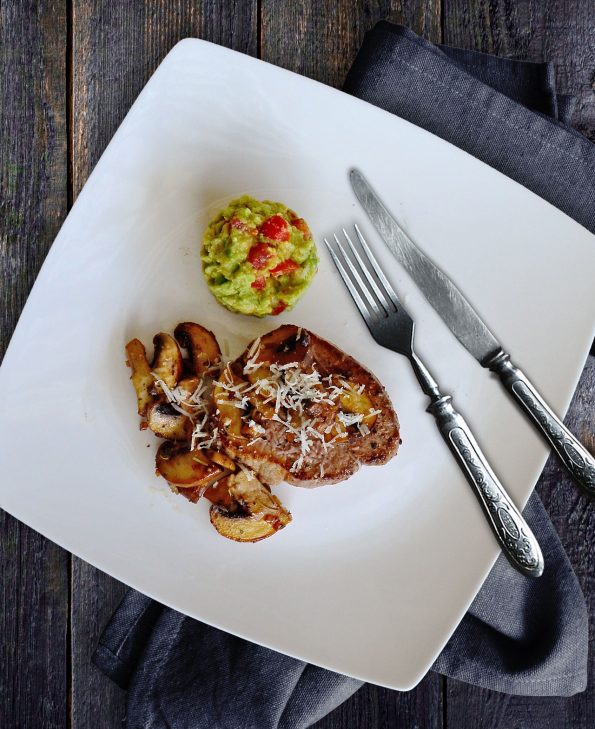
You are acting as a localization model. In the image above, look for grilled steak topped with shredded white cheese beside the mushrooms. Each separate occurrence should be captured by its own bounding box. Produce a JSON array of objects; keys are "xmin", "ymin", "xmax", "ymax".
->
[{"xmin": 215, "ymin": 325, "xmax": 400, "ymax": 487}]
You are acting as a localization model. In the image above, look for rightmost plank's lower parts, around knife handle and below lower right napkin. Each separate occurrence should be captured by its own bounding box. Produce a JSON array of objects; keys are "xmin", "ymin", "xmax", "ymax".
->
[{"xmin": 445, "ymin": 357, "xmax": 595, "ymax": 729}]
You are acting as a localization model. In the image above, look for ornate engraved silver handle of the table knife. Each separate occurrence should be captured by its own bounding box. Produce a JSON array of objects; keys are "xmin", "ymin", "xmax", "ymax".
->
[{"xmin": 486, "ymin": 352, "xmax": 595, "ymax": 496}]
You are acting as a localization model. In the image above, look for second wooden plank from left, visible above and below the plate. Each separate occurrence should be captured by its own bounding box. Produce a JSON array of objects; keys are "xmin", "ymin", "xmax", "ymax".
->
[{"xmin": 71, "ymin": 0, "xmax": 258, "ymax": 729}]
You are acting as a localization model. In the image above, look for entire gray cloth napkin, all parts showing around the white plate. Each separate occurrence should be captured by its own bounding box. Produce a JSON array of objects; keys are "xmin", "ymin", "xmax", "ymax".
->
[{"xmin": 94, "ymin": 23, "xmax": 595, "ymax": 729}]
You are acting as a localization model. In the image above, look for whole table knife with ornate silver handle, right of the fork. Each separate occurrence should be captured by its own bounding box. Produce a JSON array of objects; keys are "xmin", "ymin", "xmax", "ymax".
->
[{"xmin": 349, "ymin": 169, "xmax": 595, "ymax": 495}]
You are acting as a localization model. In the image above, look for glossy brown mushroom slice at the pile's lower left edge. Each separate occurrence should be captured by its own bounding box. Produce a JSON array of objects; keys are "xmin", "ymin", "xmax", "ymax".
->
[{"xmin": 155, "ymin": 441, "xmax": 225, "ymax": 489}]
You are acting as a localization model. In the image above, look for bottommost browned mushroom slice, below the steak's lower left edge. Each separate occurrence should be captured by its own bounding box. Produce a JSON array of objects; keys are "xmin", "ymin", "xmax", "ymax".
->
[{"xmin": 211, "ymin": 471, "xmax": 291, "ymax": 542}]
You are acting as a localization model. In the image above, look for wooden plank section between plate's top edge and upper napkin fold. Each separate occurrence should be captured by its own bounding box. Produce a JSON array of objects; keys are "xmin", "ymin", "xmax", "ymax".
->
[{"xmin": 261, "ymin": 0, "xmax": 441, "ymax": 87}]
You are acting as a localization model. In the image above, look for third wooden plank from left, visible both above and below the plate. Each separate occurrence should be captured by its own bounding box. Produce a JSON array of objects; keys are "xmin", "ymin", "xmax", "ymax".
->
[{"xmin": 261, "ymin": 0, "xmax": 442, "ymax": 729}]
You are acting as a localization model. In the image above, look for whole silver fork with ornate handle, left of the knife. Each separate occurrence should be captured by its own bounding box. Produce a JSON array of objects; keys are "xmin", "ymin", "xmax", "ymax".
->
[{"xmin": 324, "ymin": 225, "xmax": 543, "ymax": 577}]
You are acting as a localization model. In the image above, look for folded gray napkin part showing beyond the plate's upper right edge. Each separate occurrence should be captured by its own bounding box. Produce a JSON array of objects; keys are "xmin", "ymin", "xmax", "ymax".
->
[{"xmin": 345, "ymin": 22, "xmax": 595, "ymax": 233}]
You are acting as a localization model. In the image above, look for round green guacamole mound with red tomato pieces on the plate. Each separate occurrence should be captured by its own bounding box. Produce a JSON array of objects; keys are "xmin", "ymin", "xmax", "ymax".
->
[{"xmin": 201, "ymin": 195, "xmax": 318, "ymax": 316}]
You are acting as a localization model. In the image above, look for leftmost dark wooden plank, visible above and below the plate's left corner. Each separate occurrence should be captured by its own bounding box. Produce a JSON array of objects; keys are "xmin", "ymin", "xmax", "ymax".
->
[{"xmin": 0, "ymin": 0, "xmax": 69, "ymax": 729}]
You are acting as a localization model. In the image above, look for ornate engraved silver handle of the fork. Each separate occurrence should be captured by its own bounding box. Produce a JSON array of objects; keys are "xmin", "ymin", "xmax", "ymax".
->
[{"xmin": 428, "ymin": 395, "xmax": 543, "ymax": 577}]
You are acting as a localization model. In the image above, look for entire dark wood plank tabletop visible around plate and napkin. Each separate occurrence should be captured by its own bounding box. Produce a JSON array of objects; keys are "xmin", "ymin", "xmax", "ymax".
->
[{"xmin": 0, "ymin": 0, "xmax": 595, "ymax": 729}]
